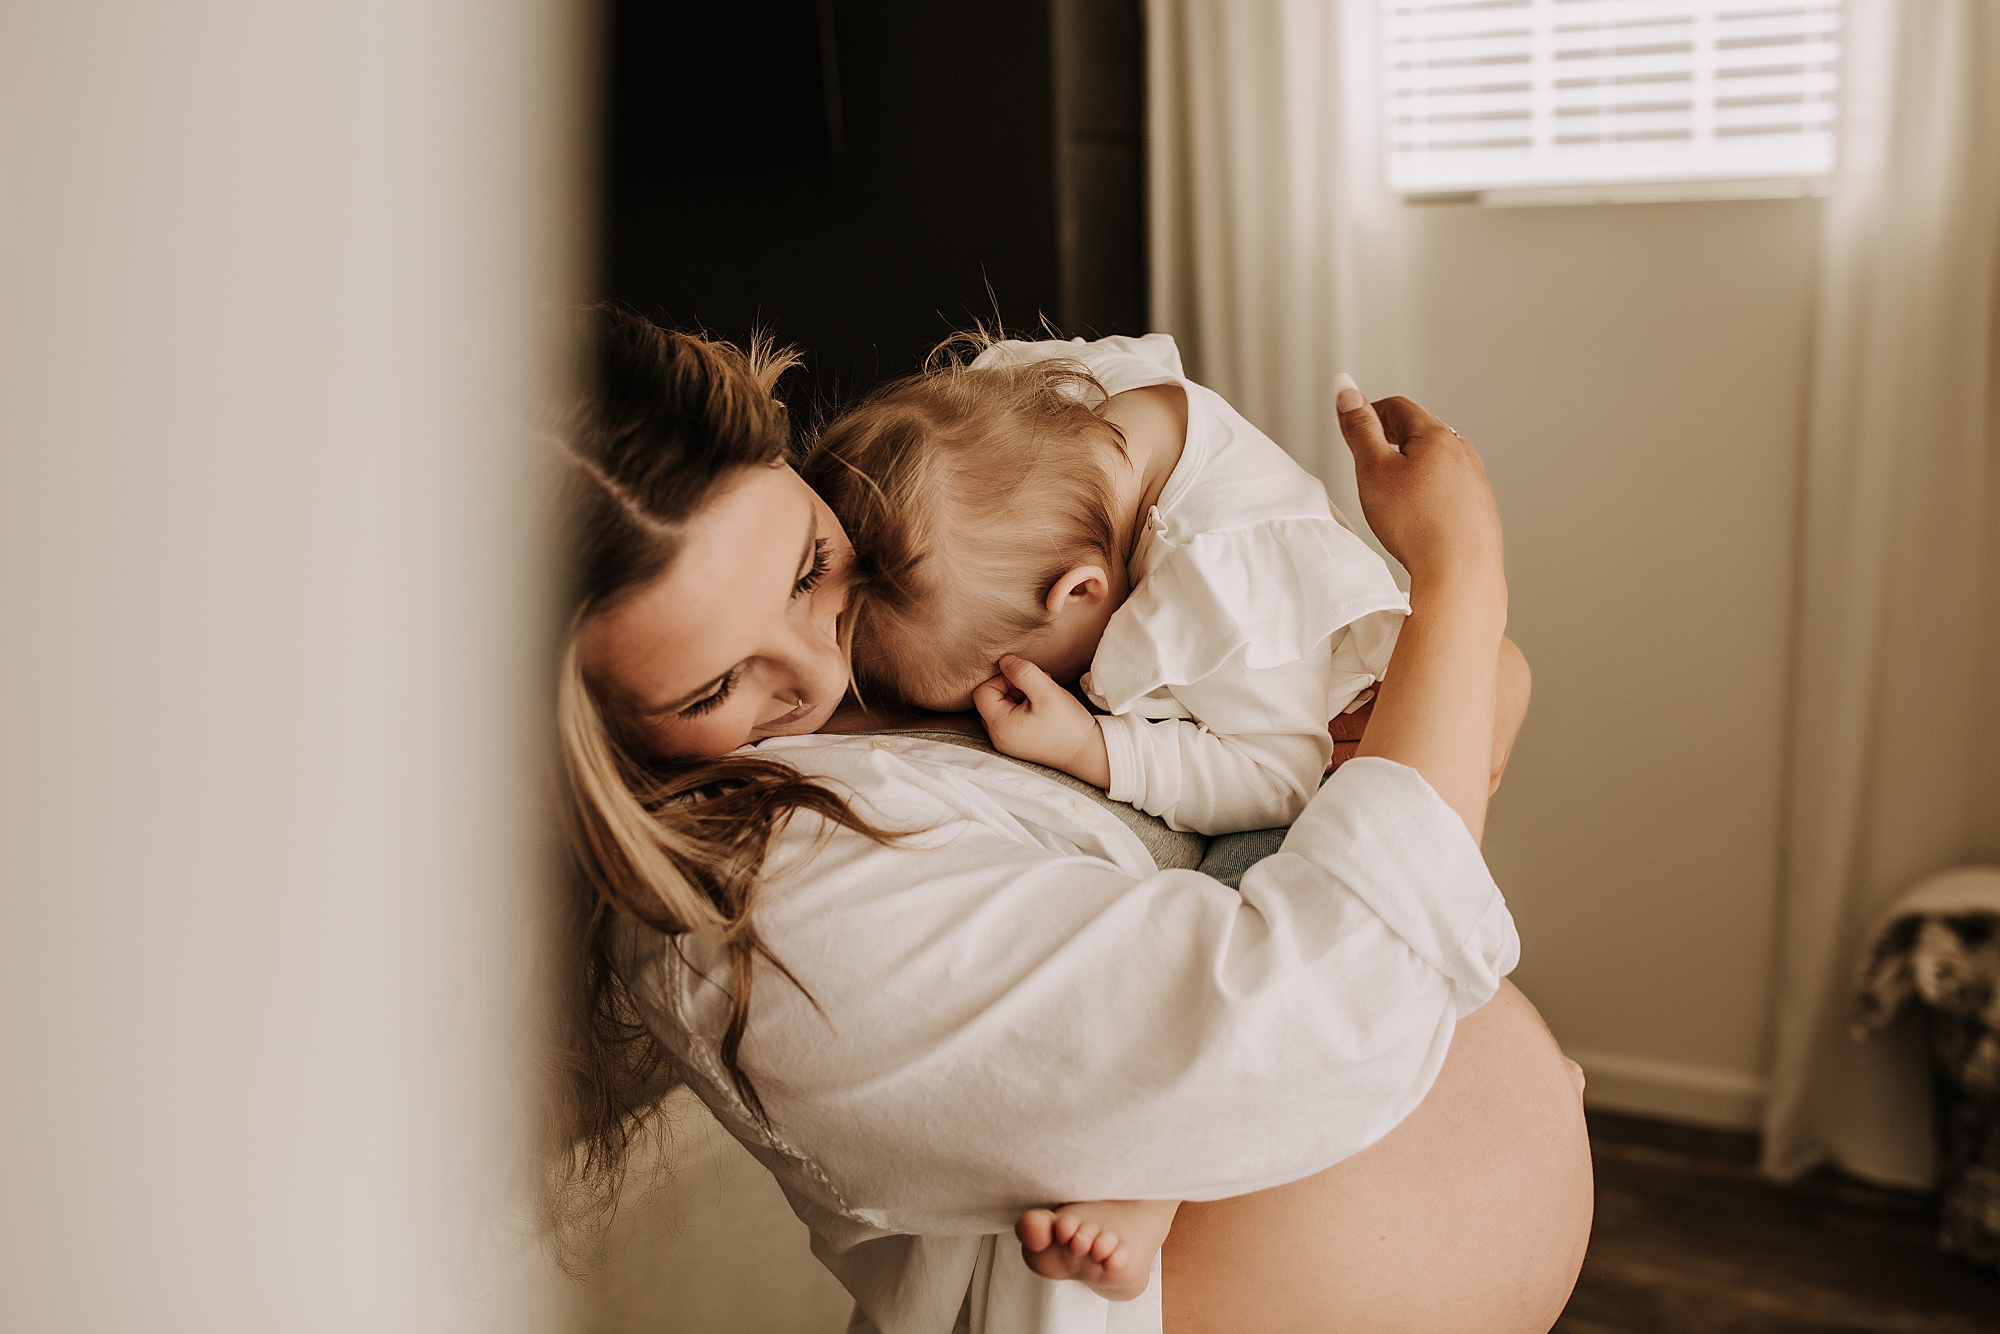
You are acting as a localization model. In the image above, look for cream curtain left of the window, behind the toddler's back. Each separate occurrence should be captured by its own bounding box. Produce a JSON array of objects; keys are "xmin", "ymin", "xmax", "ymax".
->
[{"xmin": 1146, "ymin": 0, "xmax": 1398, "ymax": 548}]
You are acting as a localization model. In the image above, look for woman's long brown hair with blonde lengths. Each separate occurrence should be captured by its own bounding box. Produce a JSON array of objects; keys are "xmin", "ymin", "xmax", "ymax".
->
[{"xmin": 548, "ymin": 306, "xmax": 880, "ymax": 1256}]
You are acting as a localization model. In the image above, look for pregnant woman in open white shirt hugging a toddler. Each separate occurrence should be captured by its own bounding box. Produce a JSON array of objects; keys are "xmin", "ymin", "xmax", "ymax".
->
[{"xmin": 560, "ymin": 314, "xmax": 1590, "ymax": 1334}]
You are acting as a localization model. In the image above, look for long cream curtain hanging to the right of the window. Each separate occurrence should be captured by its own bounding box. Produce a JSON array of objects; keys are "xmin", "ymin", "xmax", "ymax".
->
[{"xmin": 1764, "ymin": 0, "xmax": 2000, "ymax": 1184}]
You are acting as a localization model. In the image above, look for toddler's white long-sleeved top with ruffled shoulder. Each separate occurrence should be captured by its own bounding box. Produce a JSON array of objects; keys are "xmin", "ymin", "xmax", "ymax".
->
[{"xmin": 974, "ymin": 334, "xmax": 1410, "ymax": 834}]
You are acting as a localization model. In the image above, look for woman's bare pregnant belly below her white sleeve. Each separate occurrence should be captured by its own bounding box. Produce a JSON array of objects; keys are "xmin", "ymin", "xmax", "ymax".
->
[{"xmin": 1162, "ymin": 984, "xmax": 1592, "ymax": 1334}]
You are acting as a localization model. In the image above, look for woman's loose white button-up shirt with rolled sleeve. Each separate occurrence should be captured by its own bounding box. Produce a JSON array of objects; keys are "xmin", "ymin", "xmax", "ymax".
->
[{"xmin": 614, "ymin": 736, "xmax": 1518, "ymax": 1334}]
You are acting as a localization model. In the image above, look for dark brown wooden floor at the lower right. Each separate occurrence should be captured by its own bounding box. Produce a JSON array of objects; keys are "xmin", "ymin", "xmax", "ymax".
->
[{"xmin": 1556, "ymin": 1112, "xmax": 2000, "ymax": 1334}]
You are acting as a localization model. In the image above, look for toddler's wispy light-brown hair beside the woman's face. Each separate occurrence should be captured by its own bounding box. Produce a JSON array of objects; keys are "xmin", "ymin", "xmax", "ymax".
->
[{"xmin": 800, "ymin": 340, "xmax": 1124, "ymax": 704}]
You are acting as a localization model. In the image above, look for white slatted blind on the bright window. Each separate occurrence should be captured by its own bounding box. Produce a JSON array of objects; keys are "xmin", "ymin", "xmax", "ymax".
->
[{"xmin": 1378, "ymin": 0, "xmax": 1842, "ymax": 194}]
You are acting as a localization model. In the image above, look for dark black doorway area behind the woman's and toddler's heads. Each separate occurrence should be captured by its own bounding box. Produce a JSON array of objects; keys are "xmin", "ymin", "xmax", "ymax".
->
[{"xmin": 600, "ymin": 0, "xmax": 1146, "ymax": 414}]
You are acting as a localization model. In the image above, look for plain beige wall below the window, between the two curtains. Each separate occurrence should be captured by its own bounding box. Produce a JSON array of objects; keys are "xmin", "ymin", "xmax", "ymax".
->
[{"xmin": 1392, "ymin": 200, "xmax": 1818, "ymax": 1124}]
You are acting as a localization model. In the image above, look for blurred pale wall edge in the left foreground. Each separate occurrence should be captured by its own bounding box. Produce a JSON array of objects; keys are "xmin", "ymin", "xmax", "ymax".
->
[{"xmin": 0, "ymin": 0, "xmax": 588, "ymax": 1334}]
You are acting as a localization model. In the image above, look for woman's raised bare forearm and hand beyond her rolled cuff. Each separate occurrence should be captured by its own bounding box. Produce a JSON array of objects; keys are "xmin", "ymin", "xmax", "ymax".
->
[{"xmin": 1336, "ymin": 382, "xmax": 1506, "ymax": 838}]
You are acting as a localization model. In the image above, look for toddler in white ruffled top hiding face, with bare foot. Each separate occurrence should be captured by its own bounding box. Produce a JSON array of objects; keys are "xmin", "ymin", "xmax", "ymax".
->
[{"xmin": 806, "ymin": 334, "xmax": 1408, "ymax": 1298}]
